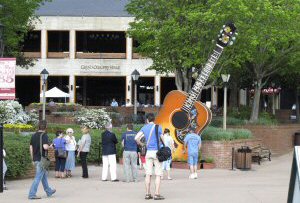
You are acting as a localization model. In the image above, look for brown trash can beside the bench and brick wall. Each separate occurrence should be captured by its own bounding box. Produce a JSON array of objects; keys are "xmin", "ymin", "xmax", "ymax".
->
[{"xmin": 235, "ymin": 146, "xmax": 252, "ymax": 169}]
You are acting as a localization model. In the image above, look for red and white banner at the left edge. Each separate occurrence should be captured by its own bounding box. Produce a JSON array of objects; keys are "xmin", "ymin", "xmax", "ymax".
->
[{"xmin": 0, "ymin": 58, "xmax": 16, "ymax": 100}]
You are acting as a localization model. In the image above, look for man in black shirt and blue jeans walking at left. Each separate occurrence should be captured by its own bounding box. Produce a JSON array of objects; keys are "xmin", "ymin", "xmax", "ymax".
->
[{"xmin": 28, "ymin": 120, "xmax": 56, "ymax": 199}]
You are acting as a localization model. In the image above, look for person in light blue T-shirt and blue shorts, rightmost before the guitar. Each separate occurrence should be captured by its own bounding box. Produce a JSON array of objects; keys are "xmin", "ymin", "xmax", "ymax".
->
[{"xmin": 183, "ymin": 127, "xmax": 201, "ymax": 179}]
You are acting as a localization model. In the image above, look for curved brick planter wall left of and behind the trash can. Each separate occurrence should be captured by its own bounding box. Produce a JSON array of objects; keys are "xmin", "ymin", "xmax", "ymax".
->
[{"xmin": 201, "ymin": 139, "xmax": 262, "ymax": 169}]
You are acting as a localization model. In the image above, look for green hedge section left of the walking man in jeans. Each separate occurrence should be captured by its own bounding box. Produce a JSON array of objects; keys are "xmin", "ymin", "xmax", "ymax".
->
[{"xmin": 4, "ymin": 133, "xmax": 31, "ymax": 178}]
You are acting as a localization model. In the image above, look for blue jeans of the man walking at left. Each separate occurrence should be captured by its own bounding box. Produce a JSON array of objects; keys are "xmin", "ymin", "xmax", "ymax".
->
[{"xmin": 28, "ymin": 161, "xmax": 54, "ymax": 199}]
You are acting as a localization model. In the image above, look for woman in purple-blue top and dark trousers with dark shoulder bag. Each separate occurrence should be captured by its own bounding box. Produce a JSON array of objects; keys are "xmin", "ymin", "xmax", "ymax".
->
[{"xmin": 53, "ymin": 130, "xmax": 67, "ymax": 178}]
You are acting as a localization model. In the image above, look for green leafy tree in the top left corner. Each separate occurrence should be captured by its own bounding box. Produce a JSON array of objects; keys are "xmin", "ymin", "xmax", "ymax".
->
[{"xmin": 0, "ymin": 0, "xmax": 45, "ymax": 67}]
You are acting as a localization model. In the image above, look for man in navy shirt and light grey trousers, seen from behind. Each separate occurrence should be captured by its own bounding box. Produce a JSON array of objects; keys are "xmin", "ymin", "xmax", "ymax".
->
[{"xmin": 122, "ymin": 124, "xmax": 137, "ymax": 183}]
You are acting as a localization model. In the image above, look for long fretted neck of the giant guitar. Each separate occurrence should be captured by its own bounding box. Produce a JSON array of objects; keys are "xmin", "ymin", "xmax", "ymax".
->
[{"xmin": 182, "ymin": 44, "xmax": 223, "ymax": 113}]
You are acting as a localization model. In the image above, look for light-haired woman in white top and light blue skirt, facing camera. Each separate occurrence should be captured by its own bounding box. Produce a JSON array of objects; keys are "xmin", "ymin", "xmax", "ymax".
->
[{"xmin": 65, "ymin": 128, "xmax": 76, "ymax": 177}]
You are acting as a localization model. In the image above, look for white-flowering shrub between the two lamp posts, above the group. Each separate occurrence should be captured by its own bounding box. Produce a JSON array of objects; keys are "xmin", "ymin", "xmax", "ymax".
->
[{"xmin": 76, "ymin": 108, "xmax": 111, "ymax": 129}]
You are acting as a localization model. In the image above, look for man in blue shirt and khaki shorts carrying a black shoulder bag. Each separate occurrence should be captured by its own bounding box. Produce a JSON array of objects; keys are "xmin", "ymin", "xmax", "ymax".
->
[{"xmin": 135, "ymin": 113, "xmax": 165, "ymax": 200}]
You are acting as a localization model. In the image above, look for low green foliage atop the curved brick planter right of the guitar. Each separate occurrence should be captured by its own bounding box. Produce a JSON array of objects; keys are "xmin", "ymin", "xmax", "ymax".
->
[{"xmin": 202, "ymin": 127, "xmax": 252, "ymax": 141}]
